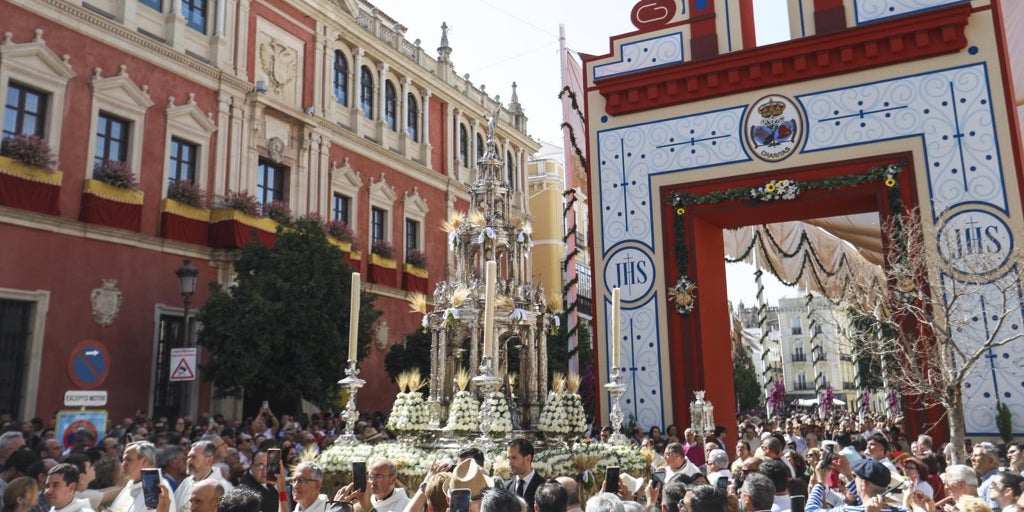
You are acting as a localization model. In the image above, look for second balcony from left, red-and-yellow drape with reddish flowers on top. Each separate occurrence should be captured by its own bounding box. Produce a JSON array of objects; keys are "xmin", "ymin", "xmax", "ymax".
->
[{"xmin": 79, "ymin": 160, "xmax": 143, "ymax": 231}]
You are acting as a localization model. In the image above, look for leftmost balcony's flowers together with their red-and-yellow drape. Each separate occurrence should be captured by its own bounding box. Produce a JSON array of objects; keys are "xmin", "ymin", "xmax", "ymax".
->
[{"xmin": 0, "ymin": 135, "xmax": 63, "ymax": 215}]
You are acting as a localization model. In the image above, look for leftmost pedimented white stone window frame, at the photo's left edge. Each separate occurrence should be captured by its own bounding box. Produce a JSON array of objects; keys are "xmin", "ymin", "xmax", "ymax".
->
[{"xmin": 0, "ymin": 29, "xmax": 75, "ymax": 157}]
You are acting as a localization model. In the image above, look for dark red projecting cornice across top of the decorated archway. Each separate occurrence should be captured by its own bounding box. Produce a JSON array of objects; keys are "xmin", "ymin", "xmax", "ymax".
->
[{"xmin": 588, "ymin": 2, "xmax": 971, "ymax": 115}]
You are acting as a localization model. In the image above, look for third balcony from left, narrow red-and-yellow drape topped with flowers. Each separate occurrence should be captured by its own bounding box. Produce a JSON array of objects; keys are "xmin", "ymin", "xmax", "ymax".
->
[{"xmin": 160, "ymin": 179, "xmax": 210, "ymax": 245}]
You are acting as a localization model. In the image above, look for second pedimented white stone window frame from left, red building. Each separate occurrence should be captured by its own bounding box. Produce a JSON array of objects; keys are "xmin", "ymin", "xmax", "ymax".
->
[{"xmin": 85, "ymin": 65, "xmax": 153, "ymax": 182}]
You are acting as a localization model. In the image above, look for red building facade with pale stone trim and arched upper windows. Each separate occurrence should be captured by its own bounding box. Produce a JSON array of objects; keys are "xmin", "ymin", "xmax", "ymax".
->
[{"xmin": 0, "ymin": 0, "xmax": 537, "ymax": 418}]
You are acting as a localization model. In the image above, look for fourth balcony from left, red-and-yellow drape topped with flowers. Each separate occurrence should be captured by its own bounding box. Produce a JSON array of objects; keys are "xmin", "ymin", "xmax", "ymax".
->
[{"xmin": 210, "ymin": 190, "xmax": 278, "ymax": 249}]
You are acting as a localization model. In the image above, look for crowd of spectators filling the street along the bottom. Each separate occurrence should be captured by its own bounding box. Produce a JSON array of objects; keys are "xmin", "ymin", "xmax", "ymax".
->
[{"xmin": 0, "ymin": 406, "xmax": 1024, "ymax": 512}]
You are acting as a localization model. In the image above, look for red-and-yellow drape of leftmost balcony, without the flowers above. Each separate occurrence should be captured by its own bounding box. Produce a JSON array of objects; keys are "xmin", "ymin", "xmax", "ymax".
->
[{"xmin": 0, "ymin": 157, "xmax": 63, "ymax": 215}]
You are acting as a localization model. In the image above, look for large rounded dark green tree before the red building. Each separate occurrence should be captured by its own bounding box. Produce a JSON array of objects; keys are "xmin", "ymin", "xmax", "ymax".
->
[{"xmin": 198, "ymin": 219, "xmax": 380, "ymax": 404}]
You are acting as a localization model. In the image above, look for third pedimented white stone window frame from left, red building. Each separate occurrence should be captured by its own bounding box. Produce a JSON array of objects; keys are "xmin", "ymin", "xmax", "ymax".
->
[{"xmin": 160, "ymin": 92, "xmax": 217, "ymax": 197}]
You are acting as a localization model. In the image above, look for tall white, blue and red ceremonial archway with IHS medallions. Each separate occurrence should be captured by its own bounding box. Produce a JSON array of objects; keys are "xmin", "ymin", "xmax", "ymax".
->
[{"xmin": 584, "ymin": 0, "xmax": 1024, "ymax": 435}]
